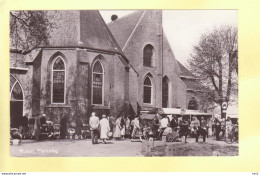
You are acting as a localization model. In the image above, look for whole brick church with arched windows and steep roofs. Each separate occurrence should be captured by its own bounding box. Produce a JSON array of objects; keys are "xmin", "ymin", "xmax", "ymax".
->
[{"xmin": 10, "ymin": 10, "xmax": 203, "ymax": 127}]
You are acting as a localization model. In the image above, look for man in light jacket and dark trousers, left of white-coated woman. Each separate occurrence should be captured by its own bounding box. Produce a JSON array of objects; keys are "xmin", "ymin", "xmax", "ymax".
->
[{"xmin": 89, "ymin": 112, "xmax": 99, "ymax": 144}]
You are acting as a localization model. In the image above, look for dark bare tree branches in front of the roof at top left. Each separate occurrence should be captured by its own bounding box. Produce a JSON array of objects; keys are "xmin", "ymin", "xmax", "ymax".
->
[{"xmin": 10, "ymin": 11, "xmax": 54, "ymax": 51}]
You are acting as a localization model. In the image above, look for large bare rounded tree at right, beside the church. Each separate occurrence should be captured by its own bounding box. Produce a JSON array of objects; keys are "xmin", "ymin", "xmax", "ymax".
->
[{"xmin": 189, "ymin": 26, "xmax": 238, "ymax": 117}]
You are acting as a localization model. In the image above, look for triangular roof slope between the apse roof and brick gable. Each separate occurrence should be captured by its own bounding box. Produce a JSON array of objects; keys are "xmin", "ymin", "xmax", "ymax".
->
[{"xmin": 107, "ymin": 10, "xmax": 144, "ymax": 48}]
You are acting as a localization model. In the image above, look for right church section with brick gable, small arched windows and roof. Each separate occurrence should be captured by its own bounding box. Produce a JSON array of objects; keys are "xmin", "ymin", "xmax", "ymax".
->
[{"xmin": 108, "ymin": 10, "xmax": 202, "ymax": 110}]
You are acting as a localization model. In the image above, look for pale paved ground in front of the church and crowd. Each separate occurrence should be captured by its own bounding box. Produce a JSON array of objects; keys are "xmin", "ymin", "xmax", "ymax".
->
[{"xmin": 10, "ymin": 138, "xmax": 238, "ymax": 157}]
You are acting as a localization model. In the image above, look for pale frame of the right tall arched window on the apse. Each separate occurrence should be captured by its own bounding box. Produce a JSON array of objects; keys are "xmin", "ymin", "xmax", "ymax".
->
[{"xmin": 91, "ymin": 59, "xmax": 105, "ymax": 106}]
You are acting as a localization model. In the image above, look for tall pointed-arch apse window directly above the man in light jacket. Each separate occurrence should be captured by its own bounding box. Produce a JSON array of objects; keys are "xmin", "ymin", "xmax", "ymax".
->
[{"xmin": 92, "ymin": 60, "xmax": 104, "ymax": 105}]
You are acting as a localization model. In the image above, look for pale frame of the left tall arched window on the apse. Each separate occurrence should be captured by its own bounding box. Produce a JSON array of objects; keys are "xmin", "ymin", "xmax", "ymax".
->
[{"xmin": 51, "ymin": 55, "xmax": 67, "ymax": 105}]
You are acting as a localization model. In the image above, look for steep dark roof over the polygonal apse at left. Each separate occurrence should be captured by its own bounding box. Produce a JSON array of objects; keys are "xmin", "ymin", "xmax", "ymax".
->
[{"xmin": 10, "ymin": 10, "xmax": 129, "ymax": 67}]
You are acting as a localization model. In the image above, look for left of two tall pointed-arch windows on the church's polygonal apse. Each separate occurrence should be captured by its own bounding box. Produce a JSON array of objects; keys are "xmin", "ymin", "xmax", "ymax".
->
[{"xmin": 52, "ymin": 56, "xmax": 66, "ymax": 104}]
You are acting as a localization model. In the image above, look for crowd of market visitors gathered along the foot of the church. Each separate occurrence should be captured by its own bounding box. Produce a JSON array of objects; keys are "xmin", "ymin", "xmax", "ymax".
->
[{"xmin": 11, "ymin": 112, "xmax": 238, "ymax": 144}]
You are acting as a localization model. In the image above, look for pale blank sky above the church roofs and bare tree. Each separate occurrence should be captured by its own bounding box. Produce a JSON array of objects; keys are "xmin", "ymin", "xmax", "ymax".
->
[{"xmin": 100, "ymin": 10, "xmax": 238, "ymax": 66}]
